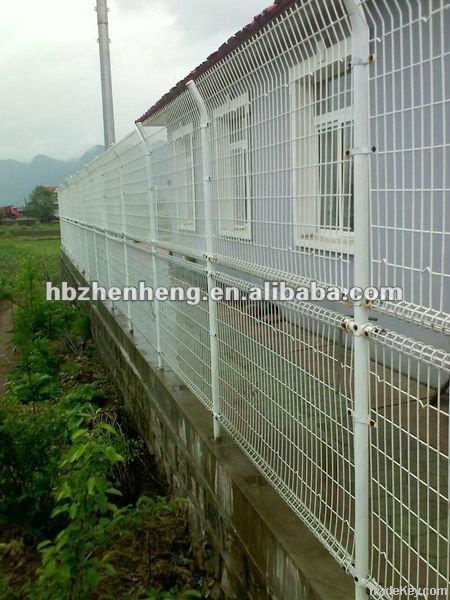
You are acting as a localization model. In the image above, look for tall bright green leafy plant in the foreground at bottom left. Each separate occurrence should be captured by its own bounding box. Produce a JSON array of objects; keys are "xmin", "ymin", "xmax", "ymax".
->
[{"xmin": 35, "ymin": 412, "xmax": 124, "ymax": 600}]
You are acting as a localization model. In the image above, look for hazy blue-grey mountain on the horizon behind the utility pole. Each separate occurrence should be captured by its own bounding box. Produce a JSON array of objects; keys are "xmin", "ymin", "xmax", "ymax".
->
[{"xmin": 0, "ymin": 146, "xmax": 103, "ymax": 206}]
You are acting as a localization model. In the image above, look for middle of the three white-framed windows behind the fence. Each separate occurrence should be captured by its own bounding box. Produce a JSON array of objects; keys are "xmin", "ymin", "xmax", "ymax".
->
[{"xmin": 214, "ymin": 94, "xmax": 251, "ymax": 239}]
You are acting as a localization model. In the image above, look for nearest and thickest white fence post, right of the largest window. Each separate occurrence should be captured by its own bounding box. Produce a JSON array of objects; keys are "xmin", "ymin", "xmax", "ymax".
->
[{"xmin": 345, "ymin": 0, "xmax": 371, "ymax": 600}]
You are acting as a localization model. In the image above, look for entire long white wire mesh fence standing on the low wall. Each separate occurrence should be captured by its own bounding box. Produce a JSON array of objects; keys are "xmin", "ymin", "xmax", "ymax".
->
[{"xmin": 59, "ymin": 0, "xmax": 450, "ymax": 599}]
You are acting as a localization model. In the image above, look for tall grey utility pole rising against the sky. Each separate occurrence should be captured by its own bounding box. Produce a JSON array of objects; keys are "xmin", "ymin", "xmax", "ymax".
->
[{"xmin": 95, "ymin": 0, "xmax": 116, "ymax": 150}]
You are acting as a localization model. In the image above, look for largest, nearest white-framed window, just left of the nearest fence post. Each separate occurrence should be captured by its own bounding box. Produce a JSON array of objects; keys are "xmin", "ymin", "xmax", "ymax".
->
[{"xmin": 290, "ymin": 41, "xmax": 353, "ymax": 251}]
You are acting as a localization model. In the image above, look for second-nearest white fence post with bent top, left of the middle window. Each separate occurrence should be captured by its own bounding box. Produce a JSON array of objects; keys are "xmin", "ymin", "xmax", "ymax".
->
[{"xmin": 187, "ymin": 80, "xmax": 221, "ymax": 441}]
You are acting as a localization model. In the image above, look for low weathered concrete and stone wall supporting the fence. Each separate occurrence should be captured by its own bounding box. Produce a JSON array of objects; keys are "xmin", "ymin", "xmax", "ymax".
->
[{"xmin": 62, "ymin": 254, "xmax": 354, "ymax": 600}]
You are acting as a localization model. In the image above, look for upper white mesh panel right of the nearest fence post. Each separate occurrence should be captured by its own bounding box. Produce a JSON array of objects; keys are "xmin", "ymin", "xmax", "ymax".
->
[{"xmin": 364, "ymin": 0, "xmax": 450, "ymax": 314}]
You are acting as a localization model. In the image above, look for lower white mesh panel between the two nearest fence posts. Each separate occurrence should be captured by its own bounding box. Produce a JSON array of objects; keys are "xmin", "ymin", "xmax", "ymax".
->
[{"xmin": 214, "ymin": 274, "xmax": 354, "ymax": 566}]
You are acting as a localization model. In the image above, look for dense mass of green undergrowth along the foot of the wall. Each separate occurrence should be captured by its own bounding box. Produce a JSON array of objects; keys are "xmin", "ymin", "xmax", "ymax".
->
[{"xmin": 0, "ymin": 241, "xmax": 200, "ymax": 600}]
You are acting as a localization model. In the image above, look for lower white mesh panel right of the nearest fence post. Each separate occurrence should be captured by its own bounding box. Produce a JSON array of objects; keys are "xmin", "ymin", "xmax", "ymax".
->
[{"xmin": 370, "ymin": 334, "xmax": 450, "ymax": 589}]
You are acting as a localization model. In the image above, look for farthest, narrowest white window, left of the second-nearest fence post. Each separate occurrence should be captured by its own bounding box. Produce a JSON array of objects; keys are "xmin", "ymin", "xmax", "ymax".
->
[{"xmin": 172, "ymin": 125, "xmax": 195, "ymax": 231}]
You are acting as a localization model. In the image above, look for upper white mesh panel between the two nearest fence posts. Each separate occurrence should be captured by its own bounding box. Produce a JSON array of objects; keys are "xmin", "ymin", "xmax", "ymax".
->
[{"xmin": 197, "ymin": 1, "xmax": 353, "ymax": 288}]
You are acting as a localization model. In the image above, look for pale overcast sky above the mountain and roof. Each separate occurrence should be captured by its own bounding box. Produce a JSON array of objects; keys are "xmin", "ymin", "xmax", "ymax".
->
[{"xmin": 0, "ymin": 0, "xmax": 270, "ymax": 161}]
